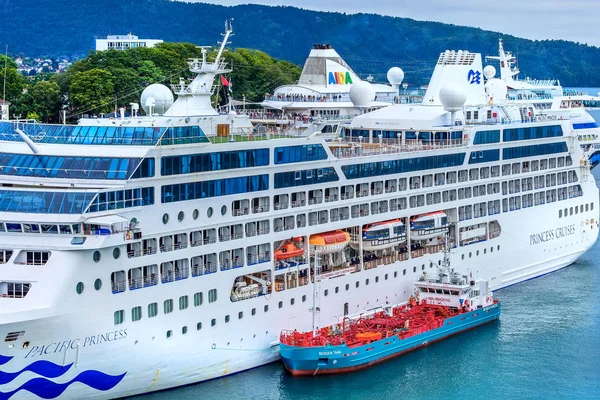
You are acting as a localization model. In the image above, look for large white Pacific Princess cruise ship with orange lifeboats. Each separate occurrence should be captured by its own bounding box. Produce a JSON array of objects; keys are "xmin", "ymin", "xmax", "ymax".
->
[{"xmin": 0, "ymin": 26, "xmax": 599, "ymax": 400}]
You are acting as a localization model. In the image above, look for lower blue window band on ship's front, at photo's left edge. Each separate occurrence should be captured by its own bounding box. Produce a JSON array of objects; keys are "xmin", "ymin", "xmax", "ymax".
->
[{"xmin": 0, "ymin": 190, "xmax": 96, "ymax": 214}]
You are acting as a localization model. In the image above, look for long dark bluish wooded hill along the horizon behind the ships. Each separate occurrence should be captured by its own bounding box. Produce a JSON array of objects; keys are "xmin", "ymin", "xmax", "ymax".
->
[{"xmin": 0, "ymin": 0, "xmax": 600, "ymax": 86}]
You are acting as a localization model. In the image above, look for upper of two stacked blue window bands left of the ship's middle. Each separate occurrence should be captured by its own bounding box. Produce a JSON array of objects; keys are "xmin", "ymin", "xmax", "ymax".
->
[{"xmin": 160, "ymin": 149, "xmax": 269, "ymax": 176}]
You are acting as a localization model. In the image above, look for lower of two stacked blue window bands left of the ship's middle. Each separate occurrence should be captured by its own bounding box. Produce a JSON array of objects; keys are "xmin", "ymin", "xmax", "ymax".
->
[{"xmin": 161, "ymin": 175, "xmax": 269, "ymax": 203}]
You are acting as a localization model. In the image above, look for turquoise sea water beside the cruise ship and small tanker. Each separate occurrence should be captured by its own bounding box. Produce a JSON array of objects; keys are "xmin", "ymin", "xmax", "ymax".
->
[{"xmin": 135, "ymin": 109, "xmax": 600, "ymax": 400}]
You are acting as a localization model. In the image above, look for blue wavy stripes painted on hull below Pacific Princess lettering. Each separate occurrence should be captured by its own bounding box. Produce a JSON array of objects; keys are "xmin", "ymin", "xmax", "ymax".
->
[{"xmin": 0, "ymin": 355, "xmax": 127, "ymax": 400}]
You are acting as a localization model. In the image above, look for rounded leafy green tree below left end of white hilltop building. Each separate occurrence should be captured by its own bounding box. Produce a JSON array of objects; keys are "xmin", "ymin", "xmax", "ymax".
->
[{"xmin": 69, "ymin": 68, "xmax": 115, "ymax": 114}]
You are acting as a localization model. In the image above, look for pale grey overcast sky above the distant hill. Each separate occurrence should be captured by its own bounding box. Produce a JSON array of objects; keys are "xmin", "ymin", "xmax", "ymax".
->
[{"xmin": 185, "ymin": 0, "xmax": 600, "ymax": 46}]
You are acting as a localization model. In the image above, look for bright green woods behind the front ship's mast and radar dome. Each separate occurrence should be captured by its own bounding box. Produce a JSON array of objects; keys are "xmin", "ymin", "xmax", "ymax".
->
[{"xmin": 0, "ymin": 43, "xmax": 301, "ymax": 122}]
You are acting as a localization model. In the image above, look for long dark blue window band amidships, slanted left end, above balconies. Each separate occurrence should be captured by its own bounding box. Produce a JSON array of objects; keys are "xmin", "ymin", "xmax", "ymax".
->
[{"xmin": 342, "ymin": 153, "xmax": 465, "ymax": 179}]
